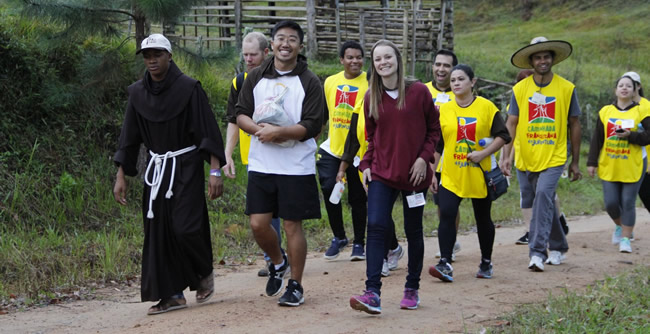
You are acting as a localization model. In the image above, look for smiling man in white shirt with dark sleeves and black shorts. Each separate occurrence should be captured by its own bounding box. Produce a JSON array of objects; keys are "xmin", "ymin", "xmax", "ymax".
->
[{"xmin": 236, "ymin": 21, "xmax": 324, "ymax": 306}]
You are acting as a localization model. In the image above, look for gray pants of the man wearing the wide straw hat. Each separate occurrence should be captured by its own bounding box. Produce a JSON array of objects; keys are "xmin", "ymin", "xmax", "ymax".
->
[{"xmin": 522, "ymin": 166, "xmax": 569, "ymax": 261}]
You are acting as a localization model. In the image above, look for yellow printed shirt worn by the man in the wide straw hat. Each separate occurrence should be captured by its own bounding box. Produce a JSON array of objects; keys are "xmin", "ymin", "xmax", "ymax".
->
[{"xmin": 512, "ymin": 74, "xmax": 575, "ymax": 172}]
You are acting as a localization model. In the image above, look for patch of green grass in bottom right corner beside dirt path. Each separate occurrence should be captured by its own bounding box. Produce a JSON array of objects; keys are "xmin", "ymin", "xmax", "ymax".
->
[{"xmin": 490, "ymin": 266, "xmax": 650, "ymax": 333}]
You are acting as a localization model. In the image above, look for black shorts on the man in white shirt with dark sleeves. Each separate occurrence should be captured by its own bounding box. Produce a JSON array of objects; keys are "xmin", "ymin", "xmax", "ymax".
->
[{"xmin": 246, "ymin": 171, "xmax": 321, "ymax": 220}]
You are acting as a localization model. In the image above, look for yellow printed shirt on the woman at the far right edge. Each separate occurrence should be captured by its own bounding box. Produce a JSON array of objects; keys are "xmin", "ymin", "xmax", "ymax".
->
[{"xmin": 598, "ymin": 104, "xmax": 648, "ymax": 183}]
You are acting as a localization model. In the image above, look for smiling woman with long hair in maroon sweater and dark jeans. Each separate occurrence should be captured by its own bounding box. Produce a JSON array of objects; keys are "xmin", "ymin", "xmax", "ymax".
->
[{"xmin": 350, "ymin": 40, "xmax": 440, "ymax": 314}]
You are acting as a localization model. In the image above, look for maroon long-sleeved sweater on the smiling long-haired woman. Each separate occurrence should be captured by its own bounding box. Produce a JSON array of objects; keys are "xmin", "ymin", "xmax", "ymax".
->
[{"xmin": 359, "ymin": 82, "xmax": 440, "ymax": 191}]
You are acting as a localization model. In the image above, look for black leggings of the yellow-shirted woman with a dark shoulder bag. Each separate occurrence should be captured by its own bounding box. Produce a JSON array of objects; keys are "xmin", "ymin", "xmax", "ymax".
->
[{"xmin": 438, "ymin": 185, "xmax": 494, "ymax": 260}]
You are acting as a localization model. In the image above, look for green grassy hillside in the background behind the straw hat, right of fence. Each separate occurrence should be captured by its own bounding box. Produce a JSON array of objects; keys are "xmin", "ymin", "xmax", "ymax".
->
[{"xmin": 454, "ymin": 0, "xmax": 650, "ymax": 113}]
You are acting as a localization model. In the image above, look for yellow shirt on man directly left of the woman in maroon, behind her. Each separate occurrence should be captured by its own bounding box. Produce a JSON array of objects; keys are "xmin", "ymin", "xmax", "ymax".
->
[{"xmin": 323, "ymin": 71, "xmax": 368, "ymax": 158}]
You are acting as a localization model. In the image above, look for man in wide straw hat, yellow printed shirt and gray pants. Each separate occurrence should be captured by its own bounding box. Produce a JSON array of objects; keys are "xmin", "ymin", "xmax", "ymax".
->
[{"xmin": 503, "ymin": 37, "xmax": 582, "ymax": 271}]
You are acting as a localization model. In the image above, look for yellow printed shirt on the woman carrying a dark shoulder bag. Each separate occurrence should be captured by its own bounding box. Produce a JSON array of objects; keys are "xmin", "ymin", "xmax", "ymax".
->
[{"xmin": 439, "ymin": 96, "xmax": 499, "ymax": 198}]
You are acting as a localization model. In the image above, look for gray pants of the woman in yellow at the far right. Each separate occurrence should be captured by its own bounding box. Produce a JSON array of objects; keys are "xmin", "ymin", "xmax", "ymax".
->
[{"xmin": 603, "ymin": 158, "xmax": 647, "ymax": 226}]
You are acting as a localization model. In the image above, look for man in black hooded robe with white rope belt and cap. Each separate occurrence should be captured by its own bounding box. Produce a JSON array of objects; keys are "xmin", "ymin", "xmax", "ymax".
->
[{"xmin": 113, "ymin": 34, "xmax": 226, "ymax": 315}]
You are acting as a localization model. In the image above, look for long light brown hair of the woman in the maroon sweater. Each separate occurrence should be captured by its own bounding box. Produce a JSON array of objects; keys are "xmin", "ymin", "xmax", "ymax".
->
[{"xmin": 367, "ymin": 39, "xmax": 415, "ymax": 120}]
